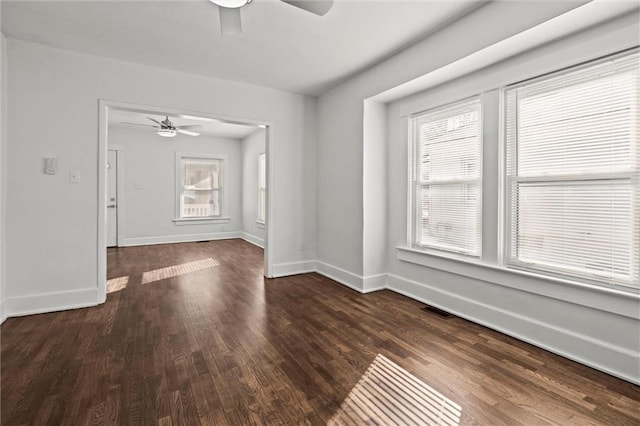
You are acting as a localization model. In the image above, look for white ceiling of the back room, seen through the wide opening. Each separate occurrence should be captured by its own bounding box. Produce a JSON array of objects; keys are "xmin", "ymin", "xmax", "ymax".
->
[{"xmin": 108, "ymin": 108, "xmax": 258, "ymax": 139}]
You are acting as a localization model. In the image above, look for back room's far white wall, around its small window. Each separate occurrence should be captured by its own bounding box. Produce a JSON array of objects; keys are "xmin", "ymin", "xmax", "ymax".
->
[{"xmin": 108, "ymin": 126, "xmax": 242, "ymax": 246}]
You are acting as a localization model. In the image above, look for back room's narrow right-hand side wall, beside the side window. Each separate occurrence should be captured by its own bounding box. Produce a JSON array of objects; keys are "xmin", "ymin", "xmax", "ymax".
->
[{"xmin": 242, "ymin": 129, "xmax": 266, "ymax": 247}]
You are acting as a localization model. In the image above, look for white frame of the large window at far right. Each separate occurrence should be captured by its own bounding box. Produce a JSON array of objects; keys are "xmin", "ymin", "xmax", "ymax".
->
[{"xmin": 499, "ymin": 48, "xmax": 640, "ymax": 292}]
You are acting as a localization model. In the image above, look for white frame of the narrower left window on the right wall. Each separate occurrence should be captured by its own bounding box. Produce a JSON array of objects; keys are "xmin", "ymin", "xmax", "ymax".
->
[{"xmin": 407, "ymin": 94, "xmax": 484, "ymax": 262}]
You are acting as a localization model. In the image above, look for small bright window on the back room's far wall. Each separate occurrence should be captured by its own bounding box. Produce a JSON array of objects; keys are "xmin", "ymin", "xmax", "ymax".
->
[{"xmin": 176, "ymin": 154, "xmax": 224, "ymax": 219}]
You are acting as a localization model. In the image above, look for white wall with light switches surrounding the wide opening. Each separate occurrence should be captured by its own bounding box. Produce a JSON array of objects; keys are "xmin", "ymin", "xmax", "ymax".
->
[{"xmin": 5, "ymin": 39, "xmax": 315, "ymax": 315}]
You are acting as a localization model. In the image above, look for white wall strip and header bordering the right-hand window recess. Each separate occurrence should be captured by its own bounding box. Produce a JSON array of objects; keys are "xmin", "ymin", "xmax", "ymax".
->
[{"xmin": 317, "ymin": 2, "xmax": 580, "ymax": 282}]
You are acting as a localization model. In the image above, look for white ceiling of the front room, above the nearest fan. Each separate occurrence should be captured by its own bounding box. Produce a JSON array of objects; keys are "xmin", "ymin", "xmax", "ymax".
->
[{"xmin": 1, "ymin": 0, "xmax": 480, "ymax": 95}]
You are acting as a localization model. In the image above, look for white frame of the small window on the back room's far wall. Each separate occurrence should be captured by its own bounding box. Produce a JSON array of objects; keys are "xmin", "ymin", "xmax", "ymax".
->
[{"xmin": 173, "ymin": 151, "xmax": 230, "ymax": 225}]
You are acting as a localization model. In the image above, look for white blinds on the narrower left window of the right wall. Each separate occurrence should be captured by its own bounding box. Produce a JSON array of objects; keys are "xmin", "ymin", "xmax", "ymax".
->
[{"xmin": 411, "ymin": 97, "xmax": 482, "ymax": 256}]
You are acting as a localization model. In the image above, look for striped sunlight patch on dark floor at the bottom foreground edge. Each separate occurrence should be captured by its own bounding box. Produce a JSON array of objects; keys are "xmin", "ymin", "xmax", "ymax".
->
[{"xmin": 328, "ymin": 354, "xmax": 462, "ymax": 426}]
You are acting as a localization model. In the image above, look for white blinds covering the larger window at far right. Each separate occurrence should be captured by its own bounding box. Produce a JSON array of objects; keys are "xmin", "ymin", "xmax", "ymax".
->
[{"xmin": 505, "ymin": 52, "xmax": 640, "ymax": 287}]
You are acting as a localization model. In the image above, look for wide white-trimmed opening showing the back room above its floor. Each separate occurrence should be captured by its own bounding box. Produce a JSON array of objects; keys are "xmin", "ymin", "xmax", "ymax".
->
[{"xmin": 98, "ymin": 101, "xmax": 272, "ymax": 303}]
